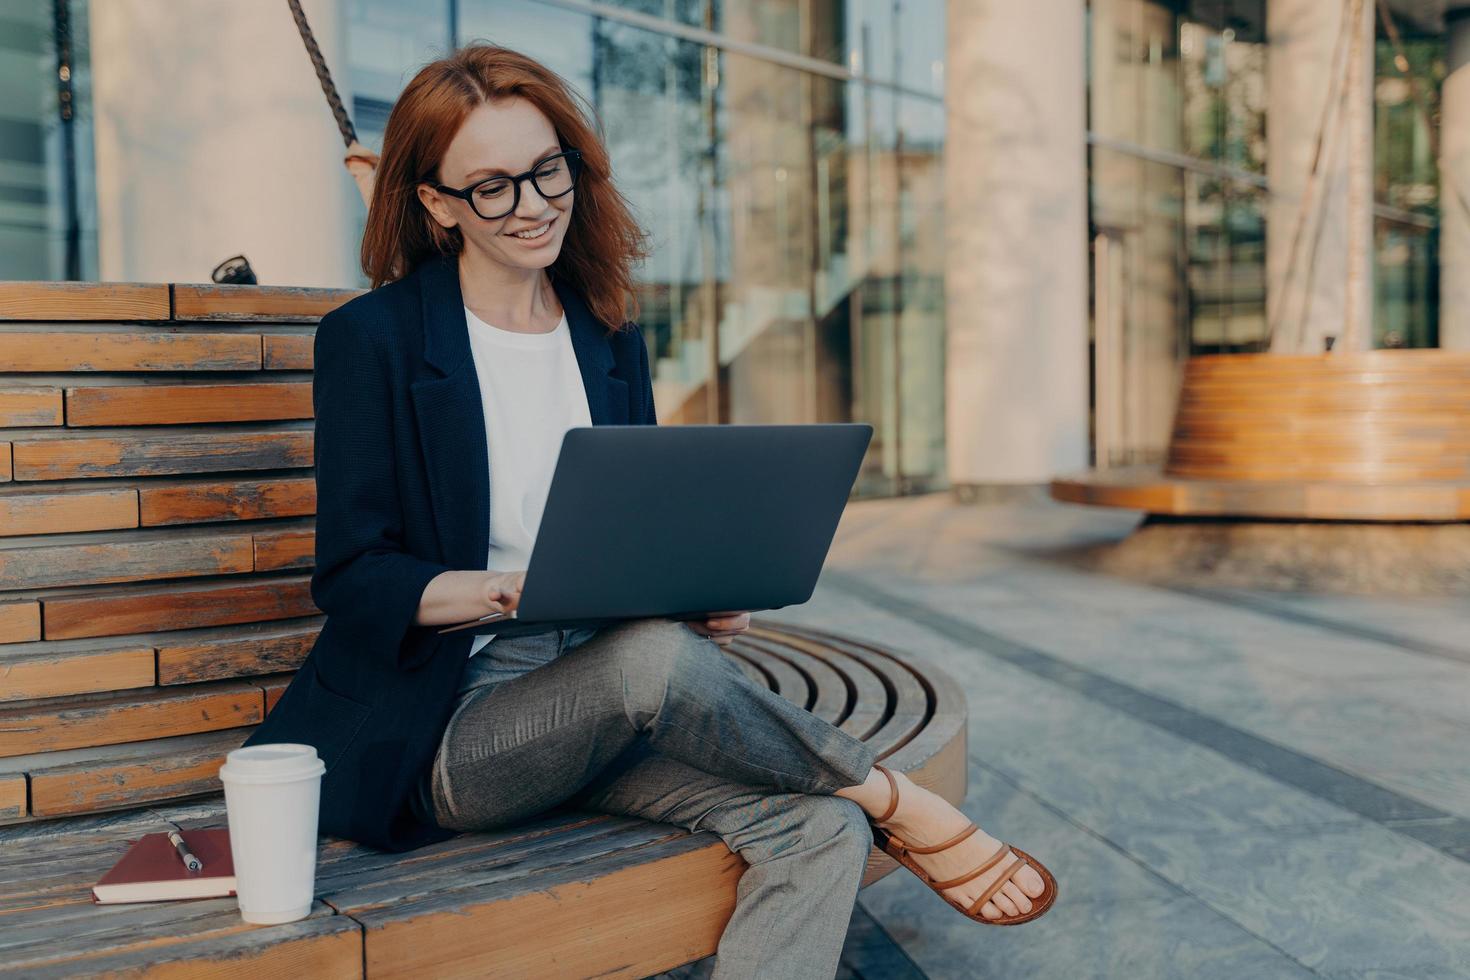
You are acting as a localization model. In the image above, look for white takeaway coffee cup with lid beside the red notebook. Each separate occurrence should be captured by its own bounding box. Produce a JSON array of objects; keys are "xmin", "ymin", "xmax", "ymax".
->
[{"xmin": 219, "ymin": 742, "xmax": 326, "ymax": 924}]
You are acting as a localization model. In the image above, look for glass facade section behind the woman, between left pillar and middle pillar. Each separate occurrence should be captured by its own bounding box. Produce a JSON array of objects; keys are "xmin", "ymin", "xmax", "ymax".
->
[{"xmin": 348, "ymin": 0, "xmax": 944, "ymax": 495}]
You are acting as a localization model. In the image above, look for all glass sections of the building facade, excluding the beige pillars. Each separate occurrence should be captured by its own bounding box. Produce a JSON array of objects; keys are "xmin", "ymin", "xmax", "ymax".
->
[{"xmin": 0, "ymin": 0, "xmax": 1470, "ymax": 495}]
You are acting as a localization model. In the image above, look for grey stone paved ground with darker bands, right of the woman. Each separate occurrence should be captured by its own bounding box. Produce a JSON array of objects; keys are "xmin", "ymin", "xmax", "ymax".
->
[{"xmin": 670, "ymin": 494, "xmax": 1470, "ymax": 980}]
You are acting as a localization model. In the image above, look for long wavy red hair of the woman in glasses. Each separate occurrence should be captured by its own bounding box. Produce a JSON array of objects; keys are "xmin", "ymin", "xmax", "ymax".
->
[{"xmin": 362, "ymin": 44, "xmax": 648, "ymax": 331}]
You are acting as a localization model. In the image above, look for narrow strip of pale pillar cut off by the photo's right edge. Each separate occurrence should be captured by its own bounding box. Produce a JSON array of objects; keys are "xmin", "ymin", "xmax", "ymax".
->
[{"xmin": 1439, "ymin": 6, "xmax": 1470, "ymax": 350}]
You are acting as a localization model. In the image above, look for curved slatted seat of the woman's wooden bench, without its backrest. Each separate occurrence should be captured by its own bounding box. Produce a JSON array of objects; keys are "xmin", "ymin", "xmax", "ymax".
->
[{"xmin": 0, "ymin": 620, "xmax": 966, "ymax": 977}]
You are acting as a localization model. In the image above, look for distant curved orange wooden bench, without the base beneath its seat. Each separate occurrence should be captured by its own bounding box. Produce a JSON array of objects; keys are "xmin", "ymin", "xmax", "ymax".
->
[{"xmin": 1051, "ymin": 350, "xmax": 1470, "ymax": 522}]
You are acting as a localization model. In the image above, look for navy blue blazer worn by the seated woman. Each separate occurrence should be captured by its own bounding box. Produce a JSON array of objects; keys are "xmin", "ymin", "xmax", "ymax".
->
[{"xmin": 244, "ymin": 257, "xmax": 657, "ymax": 851}]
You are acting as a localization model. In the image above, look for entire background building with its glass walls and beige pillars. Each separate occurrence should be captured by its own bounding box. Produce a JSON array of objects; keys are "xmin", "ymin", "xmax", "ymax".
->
[{"xmin": 0, "ymin": 0, "xmax": 1470, "ymax": 495}]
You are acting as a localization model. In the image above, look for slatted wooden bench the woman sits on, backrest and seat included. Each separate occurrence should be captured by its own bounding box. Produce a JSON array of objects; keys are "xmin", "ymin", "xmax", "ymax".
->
[{"xmin": 0, "ymin": 284, "xmax": 966, "ymax": 977}]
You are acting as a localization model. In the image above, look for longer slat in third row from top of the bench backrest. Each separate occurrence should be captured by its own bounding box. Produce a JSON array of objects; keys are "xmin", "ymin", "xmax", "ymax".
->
[{"xmin": 66, "ymin": 382, "xmax": 312, "ymax": 426}]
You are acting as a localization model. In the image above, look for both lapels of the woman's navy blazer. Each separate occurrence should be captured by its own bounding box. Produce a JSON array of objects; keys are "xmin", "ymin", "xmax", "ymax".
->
[{"xmin": 409, "ymin": 256, "xmax": 628, "ymax": 569}]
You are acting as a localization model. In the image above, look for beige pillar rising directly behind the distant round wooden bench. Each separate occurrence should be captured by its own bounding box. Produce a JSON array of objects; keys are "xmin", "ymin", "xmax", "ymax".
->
[{"xmin": 1266, "ymin": 0, "xmax": 1374, "ymax": 353}]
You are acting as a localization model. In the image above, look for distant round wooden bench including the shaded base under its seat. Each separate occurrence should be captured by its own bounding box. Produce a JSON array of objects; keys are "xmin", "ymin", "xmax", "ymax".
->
[{"xmin": 1051, "ymin": 350, "xmax": 1470, "ymax": 595}]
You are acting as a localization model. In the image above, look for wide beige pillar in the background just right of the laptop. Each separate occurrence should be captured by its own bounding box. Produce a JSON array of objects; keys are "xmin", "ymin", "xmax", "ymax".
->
[{"xmin": 944, "ymin": 0, "xmax": 1088, "ymax": 486}]
